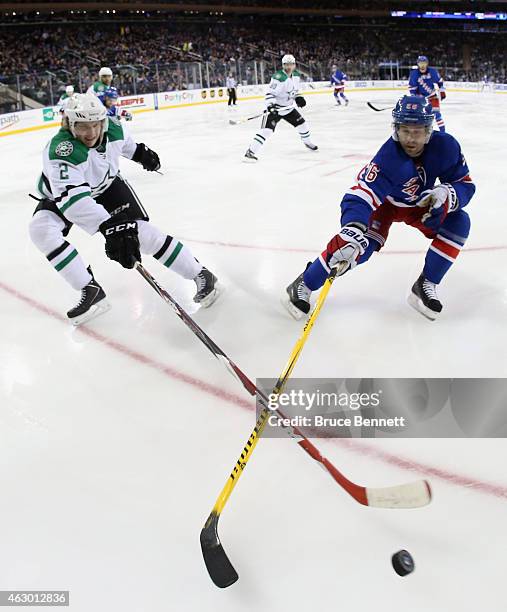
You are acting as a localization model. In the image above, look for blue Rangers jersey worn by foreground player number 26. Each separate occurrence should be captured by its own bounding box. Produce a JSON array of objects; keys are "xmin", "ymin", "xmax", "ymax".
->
[{"xmin": 341, "ymin": 131, "xmax": 475, "ymax": 225}]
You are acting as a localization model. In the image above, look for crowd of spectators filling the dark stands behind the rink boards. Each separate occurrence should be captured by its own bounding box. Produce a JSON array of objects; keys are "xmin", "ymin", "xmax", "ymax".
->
[{"xmin": 0, "ymin": 18, "xmax": 507, "ymax": 111}]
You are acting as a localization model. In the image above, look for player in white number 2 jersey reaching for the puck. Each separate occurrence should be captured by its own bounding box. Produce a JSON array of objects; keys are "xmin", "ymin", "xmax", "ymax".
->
[{"xmin": 30, "ymin": 94, "xmax": 218, "ymax": 325}]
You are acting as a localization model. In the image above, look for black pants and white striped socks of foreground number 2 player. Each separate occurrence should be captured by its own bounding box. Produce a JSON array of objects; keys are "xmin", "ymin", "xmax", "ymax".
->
[{"xmin": 29, "ymin": 175, "xmax": 202, "ymax": 290}]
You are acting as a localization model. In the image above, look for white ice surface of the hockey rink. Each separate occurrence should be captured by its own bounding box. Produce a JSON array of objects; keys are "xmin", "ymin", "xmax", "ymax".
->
[{"xmin": 0, "ymin": 87, "xmax": 507, "ymax": 612}]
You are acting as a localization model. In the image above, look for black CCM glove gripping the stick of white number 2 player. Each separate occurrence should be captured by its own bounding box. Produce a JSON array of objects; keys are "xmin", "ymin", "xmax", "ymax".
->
[{"xmin": 99, "ymin": 213, "xmax": 141, "ymax": 268}]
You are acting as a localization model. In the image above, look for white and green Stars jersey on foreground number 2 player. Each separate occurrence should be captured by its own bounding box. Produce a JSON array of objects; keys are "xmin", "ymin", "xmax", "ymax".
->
[{"xmin": 37, "ymin": 119, "xmax": 137, "ymax": 234}]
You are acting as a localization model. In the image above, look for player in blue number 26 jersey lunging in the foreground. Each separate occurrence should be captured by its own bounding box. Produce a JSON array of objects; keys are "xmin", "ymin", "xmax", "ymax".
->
[{"xmin": 285, "ymin": 96, "xmax": 475, "ymax": 320}]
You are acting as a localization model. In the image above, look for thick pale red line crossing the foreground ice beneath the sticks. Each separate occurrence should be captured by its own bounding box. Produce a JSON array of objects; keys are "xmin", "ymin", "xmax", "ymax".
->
[{"xmin": 0, "ymin": 282, "xmax": 507, "ymax": 500}]
